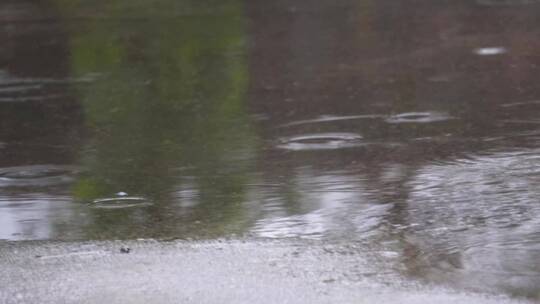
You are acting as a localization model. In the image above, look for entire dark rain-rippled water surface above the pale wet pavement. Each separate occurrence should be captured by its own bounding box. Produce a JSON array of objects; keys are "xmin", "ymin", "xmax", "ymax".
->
[{"xmin": 0, "ymin": 0, "xmax": 540, "ymax": 301}]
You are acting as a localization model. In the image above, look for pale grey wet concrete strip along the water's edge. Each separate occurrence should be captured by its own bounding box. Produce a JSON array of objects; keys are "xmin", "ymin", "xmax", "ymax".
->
[{"xmin": 0, "ymin": 240, "xmax": 532, "ymax": 304}]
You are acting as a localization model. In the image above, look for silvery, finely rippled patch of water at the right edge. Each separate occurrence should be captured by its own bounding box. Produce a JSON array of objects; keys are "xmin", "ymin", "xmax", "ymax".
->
[{"xmin": 407, "ymin": 150, "xmax": 540, "ymax": 293}]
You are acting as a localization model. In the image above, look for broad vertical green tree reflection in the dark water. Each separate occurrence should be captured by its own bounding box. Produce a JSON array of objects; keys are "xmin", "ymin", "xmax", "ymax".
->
[{"xmin": 58, "ymin": 0, "xmax": 253, "ymax": 238}]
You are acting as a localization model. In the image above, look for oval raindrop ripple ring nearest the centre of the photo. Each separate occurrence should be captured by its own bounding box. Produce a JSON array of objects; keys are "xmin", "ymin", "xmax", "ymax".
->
[{"xmin": 277, "ymin": 133, "xmax": 365, "ymax": 151}]
